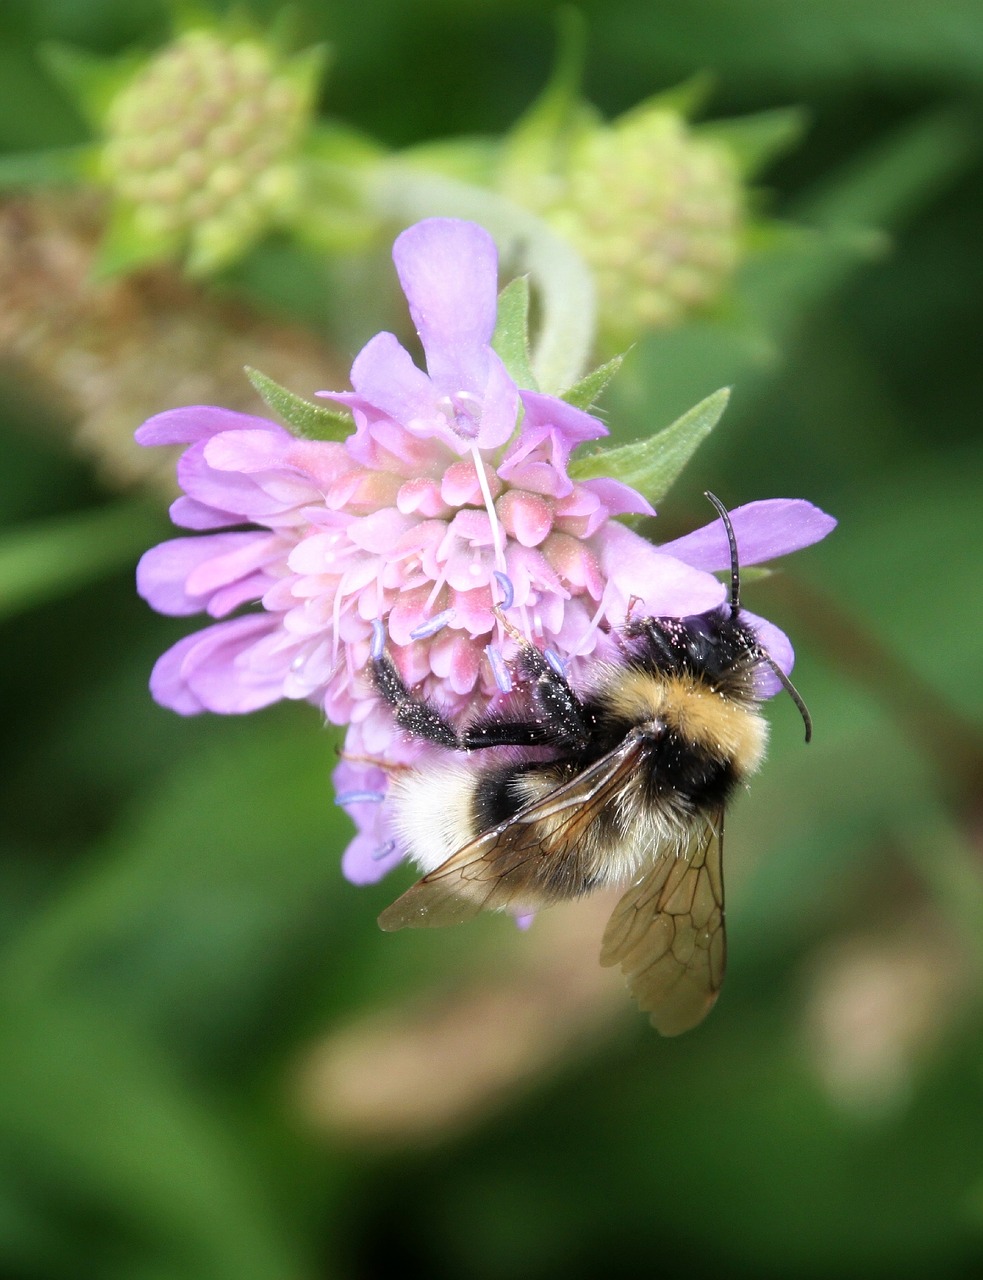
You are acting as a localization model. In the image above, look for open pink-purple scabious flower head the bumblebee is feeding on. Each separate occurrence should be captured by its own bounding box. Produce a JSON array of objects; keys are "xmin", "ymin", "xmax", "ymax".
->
[{"xmin": 137, "ymin": 218, "xmax": 835, "ymax": 883}]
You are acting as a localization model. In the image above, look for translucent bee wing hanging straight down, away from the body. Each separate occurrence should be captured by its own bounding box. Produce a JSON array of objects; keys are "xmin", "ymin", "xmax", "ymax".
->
[{"xmin": 600, "ymin": 810, "xmax": 726, "ymax": 1036}]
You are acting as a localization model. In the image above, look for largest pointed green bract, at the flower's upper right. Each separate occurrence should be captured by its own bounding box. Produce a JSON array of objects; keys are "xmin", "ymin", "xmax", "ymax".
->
[{"xmin": 570, "ymin": 387, "xmax": 731, "ymax": 503}]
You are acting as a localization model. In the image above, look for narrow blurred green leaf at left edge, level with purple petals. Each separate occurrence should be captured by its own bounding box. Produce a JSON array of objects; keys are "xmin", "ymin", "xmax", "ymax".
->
[{"xmin": 0, "ymin": 502, "xmax": 163, "ymax": 617}]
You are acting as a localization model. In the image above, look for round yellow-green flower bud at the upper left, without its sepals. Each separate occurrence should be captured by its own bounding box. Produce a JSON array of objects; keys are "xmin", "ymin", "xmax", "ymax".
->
[{"xmin": 101, "ymin": 29, "xmax": 317, "ymax": 273}]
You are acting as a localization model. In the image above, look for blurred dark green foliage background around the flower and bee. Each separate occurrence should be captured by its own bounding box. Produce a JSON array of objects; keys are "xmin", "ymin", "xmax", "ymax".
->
[{"xmin": 0, "ymin": 0, "xmax": 983, "ymax": 1280}]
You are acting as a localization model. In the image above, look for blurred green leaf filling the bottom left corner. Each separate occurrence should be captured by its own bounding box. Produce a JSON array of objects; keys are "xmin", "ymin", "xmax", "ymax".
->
[{"xmin": 0, "ymin": 998, "xmax": 308, "ymax": 1280}]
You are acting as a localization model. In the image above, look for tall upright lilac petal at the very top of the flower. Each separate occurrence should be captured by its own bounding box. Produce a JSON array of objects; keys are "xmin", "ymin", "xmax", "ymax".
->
[{"xmin": 393, "ymin": 218, "xmax": 498, "ymax": 392}]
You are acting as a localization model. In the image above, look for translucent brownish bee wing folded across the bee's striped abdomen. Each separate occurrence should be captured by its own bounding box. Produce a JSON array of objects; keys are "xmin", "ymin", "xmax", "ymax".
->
[{"xmin": 379, "ymin": 733, "xmax": 643, "ymax": 931}]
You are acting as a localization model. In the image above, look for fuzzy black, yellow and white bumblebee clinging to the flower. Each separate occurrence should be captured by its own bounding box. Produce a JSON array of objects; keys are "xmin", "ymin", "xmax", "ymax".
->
[{"xmin": 370, "ymin": 493, "xmax": 811, "ymax": 1036}]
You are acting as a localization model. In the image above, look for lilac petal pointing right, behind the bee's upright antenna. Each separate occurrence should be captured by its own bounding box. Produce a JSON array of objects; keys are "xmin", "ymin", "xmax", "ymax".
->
[{"xmin": 660, "ymin": 498, "xmax": 836, "ymax": 571}]
